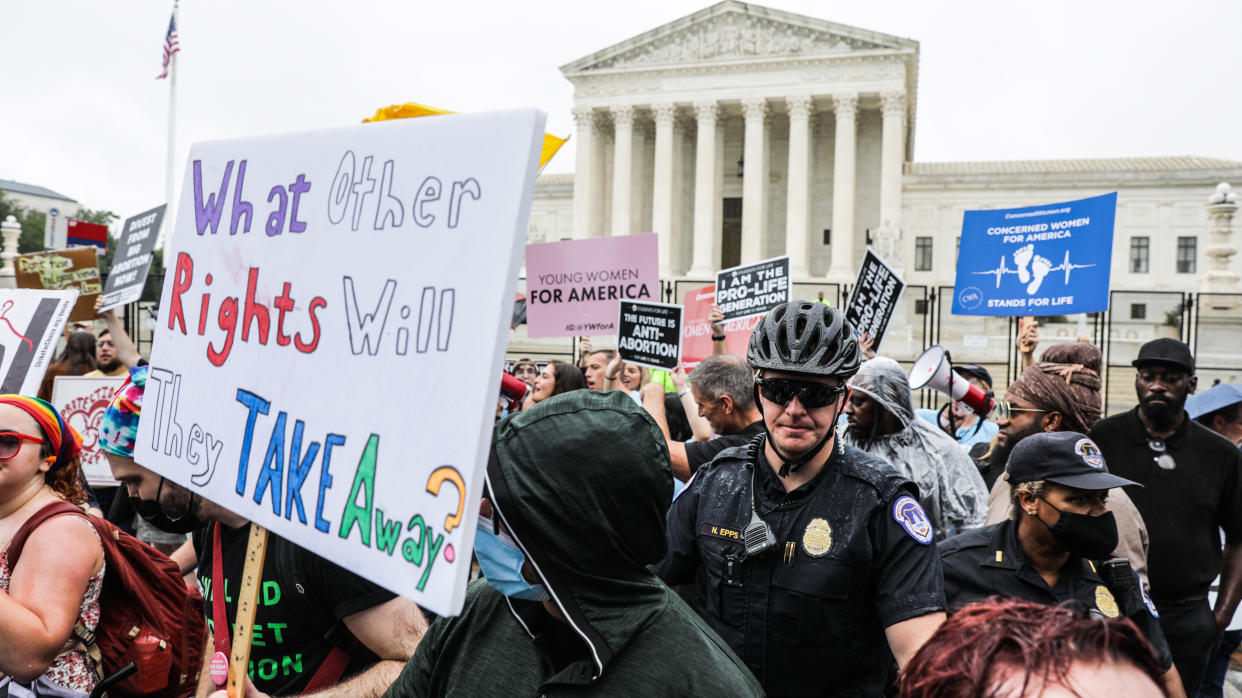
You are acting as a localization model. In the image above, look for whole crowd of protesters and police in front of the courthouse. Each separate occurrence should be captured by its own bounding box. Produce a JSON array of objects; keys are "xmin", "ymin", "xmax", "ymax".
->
[{"xmin": 0, "ymin": 294, "xmax": 1242, "ymax": 698}]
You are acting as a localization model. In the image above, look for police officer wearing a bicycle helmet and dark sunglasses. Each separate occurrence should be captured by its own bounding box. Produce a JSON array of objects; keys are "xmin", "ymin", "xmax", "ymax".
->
[{"xmin": 656, "ymin": 302, "xmax": 944, "ymax": 696}]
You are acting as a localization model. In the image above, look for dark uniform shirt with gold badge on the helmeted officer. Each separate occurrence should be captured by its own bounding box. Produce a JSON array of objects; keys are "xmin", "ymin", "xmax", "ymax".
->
[{"xmin": 655, "ymin": 436, "xmax": 944, "ymax": 696}]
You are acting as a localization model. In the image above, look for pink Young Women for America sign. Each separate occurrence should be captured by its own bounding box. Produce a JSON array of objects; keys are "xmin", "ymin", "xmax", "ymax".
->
[{"xmin": 527, "ymin": 232, "xmax": 660, "ymax": 337}]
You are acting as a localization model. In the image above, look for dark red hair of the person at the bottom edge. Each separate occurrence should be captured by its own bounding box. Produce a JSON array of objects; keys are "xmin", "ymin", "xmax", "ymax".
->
[{"xmin": 898, "ymin": 596, "xmax": 1167, "ymax": 698}]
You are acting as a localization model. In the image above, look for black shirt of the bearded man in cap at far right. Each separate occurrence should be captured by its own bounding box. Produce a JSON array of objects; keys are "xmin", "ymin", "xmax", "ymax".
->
[{"xmin": 1090, "ymin": 407, "xmax": 1242, "ymax": 604}]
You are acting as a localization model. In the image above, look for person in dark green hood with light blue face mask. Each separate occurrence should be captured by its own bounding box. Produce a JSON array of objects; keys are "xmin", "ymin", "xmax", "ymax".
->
[{"xmin": 385, "ymin": 390, "xmax": 763, "ymax": 698}]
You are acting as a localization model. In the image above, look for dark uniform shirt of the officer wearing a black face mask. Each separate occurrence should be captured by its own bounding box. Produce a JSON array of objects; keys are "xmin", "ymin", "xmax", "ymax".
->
[{"xmin": 939, "ymin": 520, "xmax": 1172, "ymax": 671}]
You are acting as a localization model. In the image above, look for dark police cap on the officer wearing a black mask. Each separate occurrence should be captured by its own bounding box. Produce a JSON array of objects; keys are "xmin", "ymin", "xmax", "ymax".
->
[{"xmin": 1005, "ymin": 431, "xmax": 1138, "ymax": 489}]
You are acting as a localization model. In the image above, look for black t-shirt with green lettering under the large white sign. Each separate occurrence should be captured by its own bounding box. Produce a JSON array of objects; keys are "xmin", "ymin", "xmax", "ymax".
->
[{"xmin": 194, "ymin": 525, "xmax": 396, "ymax": 696}]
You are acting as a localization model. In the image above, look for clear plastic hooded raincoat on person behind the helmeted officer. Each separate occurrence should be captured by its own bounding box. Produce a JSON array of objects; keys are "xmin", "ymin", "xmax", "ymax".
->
[{"xmin": 841, "ymin": 356, "xmax": 987, "ymax": 540}]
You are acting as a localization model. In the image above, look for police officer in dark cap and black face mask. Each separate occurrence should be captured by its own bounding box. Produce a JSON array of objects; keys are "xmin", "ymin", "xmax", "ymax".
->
[{"xmin": 940, "ymin": 431, "xmax": 1185, "ymax": 696}]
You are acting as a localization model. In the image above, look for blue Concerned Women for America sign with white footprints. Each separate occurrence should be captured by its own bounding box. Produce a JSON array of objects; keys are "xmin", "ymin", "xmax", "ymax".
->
[{"xmin": 953, "ymin": 191, "xmax": 1117, "ymax": 315}]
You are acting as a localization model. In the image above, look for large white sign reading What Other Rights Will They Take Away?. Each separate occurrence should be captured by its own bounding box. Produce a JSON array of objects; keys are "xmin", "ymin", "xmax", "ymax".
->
[{"xmin": 134, "ymin": 109, "xmax": 544, "ymax": 615}]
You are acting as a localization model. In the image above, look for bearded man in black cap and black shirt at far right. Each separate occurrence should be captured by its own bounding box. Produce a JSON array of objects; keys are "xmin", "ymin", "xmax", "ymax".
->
[{"xmin": 1090, "ymin": 338, "xmax": 1242, "ymax": 696}]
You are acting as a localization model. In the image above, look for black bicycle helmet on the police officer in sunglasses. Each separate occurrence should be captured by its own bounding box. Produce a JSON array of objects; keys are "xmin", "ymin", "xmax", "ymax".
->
[{"xmin": 746, "ymin": 301, "xmax": 862, "ymax": 380}]
